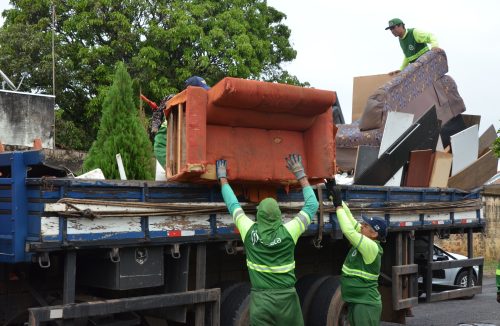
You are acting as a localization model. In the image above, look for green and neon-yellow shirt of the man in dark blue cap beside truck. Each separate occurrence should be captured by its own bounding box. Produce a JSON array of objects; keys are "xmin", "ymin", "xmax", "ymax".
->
[{"xmin": 337, "ymin": 203, "xmax": 384, "ymax": 305}]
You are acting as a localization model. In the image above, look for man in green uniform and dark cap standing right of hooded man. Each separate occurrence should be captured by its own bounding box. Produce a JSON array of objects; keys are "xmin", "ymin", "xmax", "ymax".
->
[{"xmin": 327, "ymin": 183, "xmax": 387, "ymax": 326}]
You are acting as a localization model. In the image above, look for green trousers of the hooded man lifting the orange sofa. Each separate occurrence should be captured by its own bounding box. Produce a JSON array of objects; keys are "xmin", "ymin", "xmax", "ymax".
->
[{"xmin": 250, "ymin": 288, "xmax": 304, "ymax": 326}]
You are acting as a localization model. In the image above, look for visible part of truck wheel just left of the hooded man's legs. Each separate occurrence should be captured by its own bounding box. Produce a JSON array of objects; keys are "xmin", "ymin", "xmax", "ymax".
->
[{"xmin": 220, "ymin": 282, "xmax": 250, "ymax": 326}]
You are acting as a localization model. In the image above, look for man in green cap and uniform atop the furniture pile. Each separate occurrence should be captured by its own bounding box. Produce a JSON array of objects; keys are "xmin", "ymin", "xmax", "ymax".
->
[{"xmin": 385, "ymin": 18, "xmax": 441, "ymax": 74}]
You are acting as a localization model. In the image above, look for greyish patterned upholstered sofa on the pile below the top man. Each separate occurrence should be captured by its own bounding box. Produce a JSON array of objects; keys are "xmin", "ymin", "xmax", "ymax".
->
[{"xmin": 336, "ymin": 51, "xmax": 465, "ymax": 171}]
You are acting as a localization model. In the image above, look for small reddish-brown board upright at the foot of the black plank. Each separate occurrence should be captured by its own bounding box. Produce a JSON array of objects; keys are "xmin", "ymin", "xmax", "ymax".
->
[{"xmin": 405, "ymin": 149, "xmax": 434, "ymax": 187}]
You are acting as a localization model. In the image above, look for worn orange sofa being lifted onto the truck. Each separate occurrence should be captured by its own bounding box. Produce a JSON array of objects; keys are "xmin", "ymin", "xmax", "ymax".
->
[{"xmin": 165, "ymin": 78, "xmax": 336, "ymax": 185}]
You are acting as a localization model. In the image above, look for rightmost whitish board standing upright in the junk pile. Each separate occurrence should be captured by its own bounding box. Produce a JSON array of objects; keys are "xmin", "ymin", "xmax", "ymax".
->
[{"xmin": 450, "ymin": 125, "xmax": 479, "ymax": 176}]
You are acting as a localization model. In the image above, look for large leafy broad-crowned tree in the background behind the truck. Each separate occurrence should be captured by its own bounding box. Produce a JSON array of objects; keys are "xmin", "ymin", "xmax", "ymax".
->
[{"xmin": 0, "ymin": 0, "xmax": 300, "ymax": 149}]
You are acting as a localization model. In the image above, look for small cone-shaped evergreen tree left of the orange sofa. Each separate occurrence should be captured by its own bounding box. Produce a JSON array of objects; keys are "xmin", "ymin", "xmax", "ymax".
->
[{"xmin": 83, "ymin": 62, "xmax": 154, "ymax": 180}]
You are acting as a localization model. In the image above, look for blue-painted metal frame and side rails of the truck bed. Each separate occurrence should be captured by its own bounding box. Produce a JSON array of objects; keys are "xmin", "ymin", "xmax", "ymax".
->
[{"xmin": 0, "ymin": 151, "xmax": 481, "ymax": 263}]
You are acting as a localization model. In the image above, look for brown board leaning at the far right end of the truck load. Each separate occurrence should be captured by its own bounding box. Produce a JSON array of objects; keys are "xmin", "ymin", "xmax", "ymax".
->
[{"xmin": 448, "ymin": 150, "xmax": 498, "ymax": 190}]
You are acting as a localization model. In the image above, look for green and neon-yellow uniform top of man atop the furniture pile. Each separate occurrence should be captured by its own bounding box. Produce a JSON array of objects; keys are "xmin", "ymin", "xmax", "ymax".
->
[{"xmin": 399, "ymin": 28, "xmax": 439, "ymax": 70}]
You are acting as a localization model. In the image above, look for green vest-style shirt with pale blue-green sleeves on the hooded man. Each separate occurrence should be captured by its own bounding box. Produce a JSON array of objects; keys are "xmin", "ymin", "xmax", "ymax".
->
[{"xmin": 222, "ymin": 184, "xmax": 319, "ymax": 289}]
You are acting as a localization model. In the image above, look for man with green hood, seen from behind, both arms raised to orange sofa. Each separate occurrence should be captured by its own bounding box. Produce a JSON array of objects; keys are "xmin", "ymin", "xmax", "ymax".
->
[{"xmin": 216, "ymin": 154, "xmax": 319, "ymax": 326}]
